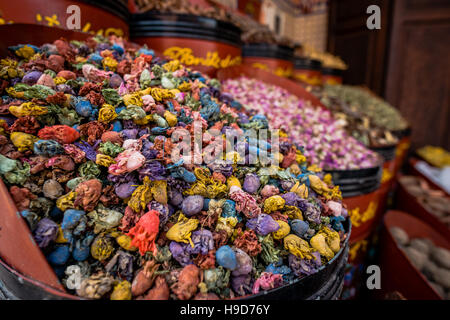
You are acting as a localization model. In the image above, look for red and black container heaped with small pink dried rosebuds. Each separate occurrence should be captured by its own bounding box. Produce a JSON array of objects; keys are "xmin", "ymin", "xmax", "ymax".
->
[{"xmin": 219, "ymin": 75, "xmax": 381, "ymax": 243}]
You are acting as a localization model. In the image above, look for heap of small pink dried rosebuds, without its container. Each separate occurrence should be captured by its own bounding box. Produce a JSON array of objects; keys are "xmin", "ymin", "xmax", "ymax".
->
[{"xmin": 222, "ymin": 77, "xmax": 380, "ymax": 170}]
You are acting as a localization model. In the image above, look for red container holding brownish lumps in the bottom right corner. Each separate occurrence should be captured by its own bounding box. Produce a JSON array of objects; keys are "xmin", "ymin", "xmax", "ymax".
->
[{"xmin": 378, "ymin": 211, "xmax": 450, "ymax": 300}]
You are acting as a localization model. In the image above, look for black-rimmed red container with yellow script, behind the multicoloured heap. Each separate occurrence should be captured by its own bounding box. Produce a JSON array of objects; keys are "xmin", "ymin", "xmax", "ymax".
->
[{"xmin": 130, "ymin": 12, "xmax": 242, "ymax": 75}]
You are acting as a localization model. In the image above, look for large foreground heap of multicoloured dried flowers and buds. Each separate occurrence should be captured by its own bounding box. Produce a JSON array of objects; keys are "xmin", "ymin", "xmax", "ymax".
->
[{"xmin": 0, "ymin": 37, "xmax": 349, "ymax": 300}]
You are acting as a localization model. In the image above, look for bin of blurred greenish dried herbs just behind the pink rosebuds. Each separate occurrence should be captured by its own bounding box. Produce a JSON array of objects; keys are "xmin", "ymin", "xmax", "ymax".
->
[{"xmin": 312, "ymin": 85, "xmax": 408, "ymax": 213}]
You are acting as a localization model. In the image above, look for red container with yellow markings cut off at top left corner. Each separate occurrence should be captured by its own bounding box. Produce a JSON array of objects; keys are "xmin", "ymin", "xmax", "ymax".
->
[{"xmin": 0, "ymin": 0, "xmax": 129, "ymax": 37}]
